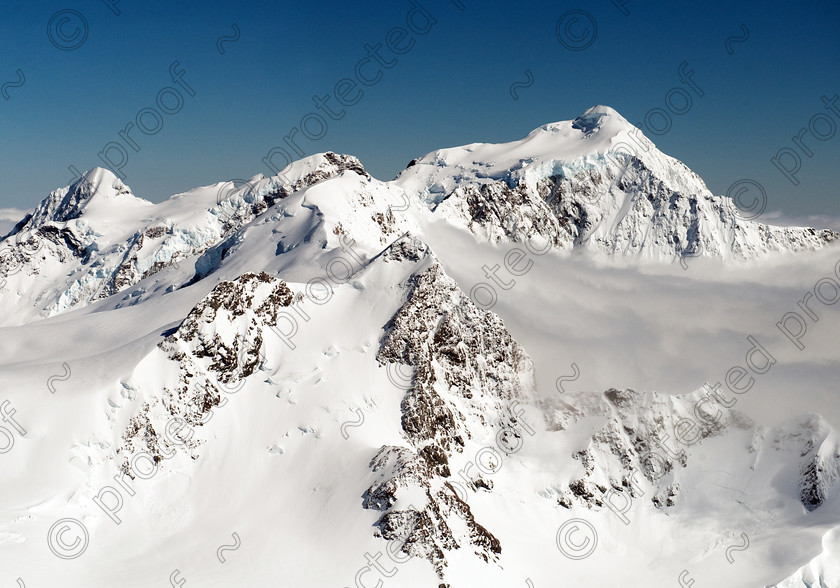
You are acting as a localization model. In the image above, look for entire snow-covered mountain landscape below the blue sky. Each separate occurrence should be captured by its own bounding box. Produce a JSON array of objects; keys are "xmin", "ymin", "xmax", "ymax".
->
[{"xmin": 0, "ymin": 106, "xmax": 840, "ymax": 588}]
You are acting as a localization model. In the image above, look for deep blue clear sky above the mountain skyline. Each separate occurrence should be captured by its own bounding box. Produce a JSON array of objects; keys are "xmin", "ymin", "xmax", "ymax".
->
[{"xmin": 0, "ymin": 0, "xmax": 840, "ymax": 217}]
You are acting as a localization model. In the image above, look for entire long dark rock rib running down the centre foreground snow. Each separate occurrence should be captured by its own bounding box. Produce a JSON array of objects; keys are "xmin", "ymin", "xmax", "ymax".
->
[{"xmin": 364, "ymin": 235, "xmax": 532, "ymax": 578}]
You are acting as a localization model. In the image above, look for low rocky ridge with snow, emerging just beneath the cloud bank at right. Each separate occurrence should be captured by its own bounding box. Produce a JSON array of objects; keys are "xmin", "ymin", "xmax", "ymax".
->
[{"xmin": 544, "ymin": 389, "xmax": 840, "ymax": 511}]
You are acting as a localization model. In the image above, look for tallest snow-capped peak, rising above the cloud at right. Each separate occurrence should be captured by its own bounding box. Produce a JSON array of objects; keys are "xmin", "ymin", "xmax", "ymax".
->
[{"xmin": 395, "ymin": 106, "xmax": 838, "ymax": 260}]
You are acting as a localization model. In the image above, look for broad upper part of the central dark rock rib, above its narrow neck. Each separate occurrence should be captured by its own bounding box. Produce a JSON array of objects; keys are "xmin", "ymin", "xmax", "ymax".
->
[{"xmin": 379, "ymin": 262, "xmax": 530, "ymax": 453}]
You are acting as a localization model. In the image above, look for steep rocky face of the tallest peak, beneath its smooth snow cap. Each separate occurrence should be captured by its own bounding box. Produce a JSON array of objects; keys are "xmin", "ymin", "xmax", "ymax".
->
[{"xmin": 434, "ymin": 154, "xmax": 838, "ymax": 259}]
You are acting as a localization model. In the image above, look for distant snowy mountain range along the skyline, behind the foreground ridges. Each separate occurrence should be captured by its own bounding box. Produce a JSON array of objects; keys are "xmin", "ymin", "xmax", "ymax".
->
[{"xmin": 0, "ymin": 106, "xmax": 838, "ymax": 320}]
